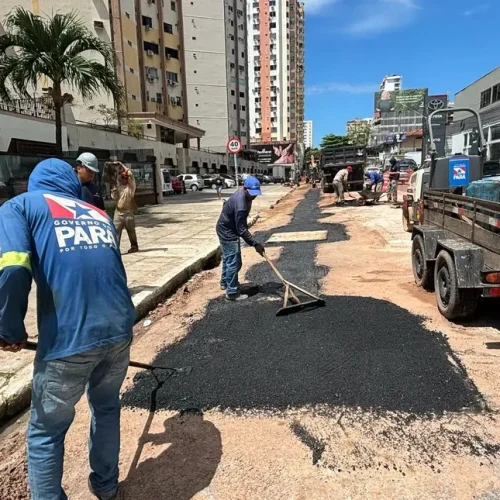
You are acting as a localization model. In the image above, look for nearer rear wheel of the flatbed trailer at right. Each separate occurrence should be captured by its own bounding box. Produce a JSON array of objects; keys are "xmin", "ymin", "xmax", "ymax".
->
[{"xmin": 434, "ymin": 250, "xmax": 481, "ymax": 320}]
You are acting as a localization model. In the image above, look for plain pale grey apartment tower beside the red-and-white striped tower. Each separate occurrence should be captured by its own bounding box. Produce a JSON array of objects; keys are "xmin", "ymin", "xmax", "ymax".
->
[{"xmin": 182, "ymin": 0, "xmax": 250, "ymax": 151}]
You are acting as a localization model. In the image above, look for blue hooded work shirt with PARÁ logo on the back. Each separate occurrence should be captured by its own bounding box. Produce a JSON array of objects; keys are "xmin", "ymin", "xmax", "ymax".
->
[{"xmin": 0, "ymin": 159, "xmax": 135, "ymax": 360}]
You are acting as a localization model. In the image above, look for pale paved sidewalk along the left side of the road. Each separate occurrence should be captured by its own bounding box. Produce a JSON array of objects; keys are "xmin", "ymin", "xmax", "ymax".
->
[{"xmin": 0, "ymin": 185, "xmax": 290, "ymax": 420}]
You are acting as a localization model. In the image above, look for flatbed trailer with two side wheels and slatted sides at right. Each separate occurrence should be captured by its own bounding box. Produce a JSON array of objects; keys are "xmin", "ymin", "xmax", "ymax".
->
[{"xmin": 412, "ymin": 189, "xmax": 500, "ymax": 320}]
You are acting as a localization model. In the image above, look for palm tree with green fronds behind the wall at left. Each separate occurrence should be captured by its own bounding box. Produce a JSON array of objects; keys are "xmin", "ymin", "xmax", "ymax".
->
[{"xmin": 0, "ymin": 7, "xmax": 122, "ymax": 154}]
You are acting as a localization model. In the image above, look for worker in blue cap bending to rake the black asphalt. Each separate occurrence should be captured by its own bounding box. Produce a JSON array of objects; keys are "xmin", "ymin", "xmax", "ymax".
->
[{"xmin": 217, "ymin": 176, "xmax": 264, "ymax": 300}]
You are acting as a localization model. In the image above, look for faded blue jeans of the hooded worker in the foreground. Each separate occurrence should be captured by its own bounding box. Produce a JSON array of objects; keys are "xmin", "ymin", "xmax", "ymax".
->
[{"xmin": 28, "ymin": 339, "xmax": 131, "ymax": 500}]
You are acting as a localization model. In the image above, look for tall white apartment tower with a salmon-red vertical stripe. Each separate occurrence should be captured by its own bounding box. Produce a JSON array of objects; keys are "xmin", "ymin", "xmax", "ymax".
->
[{"xmin": 247, "ymin": 0, "xmax": 304, "ymax": 143}]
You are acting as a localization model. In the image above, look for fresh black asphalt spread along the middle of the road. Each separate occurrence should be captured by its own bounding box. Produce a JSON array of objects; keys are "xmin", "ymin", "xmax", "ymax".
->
[{"xmin": 123, "ymin": 190, "xmax": 484, "ymax": 415}]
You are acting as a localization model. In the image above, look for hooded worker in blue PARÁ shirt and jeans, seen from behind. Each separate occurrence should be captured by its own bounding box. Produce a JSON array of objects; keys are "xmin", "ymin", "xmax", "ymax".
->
[{"xmin": 0, "ymin": 159, "xmax": 135, "ymax": 500}]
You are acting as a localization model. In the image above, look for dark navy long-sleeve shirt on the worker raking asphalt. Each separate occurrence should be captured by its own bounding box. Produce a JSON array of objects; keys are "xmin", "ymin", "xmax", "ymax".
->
[{"xmin": 217, "ymin": 189, "xmax": 257, "ymax": 247}]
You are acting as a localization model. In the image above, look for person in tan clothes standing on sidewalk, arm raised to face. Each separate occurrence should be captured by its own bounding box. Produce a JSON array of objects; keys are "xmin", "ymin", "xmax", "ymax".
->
[{"xmin": 111, "ymin": 162, "xmax": 139, "ymax": 253}]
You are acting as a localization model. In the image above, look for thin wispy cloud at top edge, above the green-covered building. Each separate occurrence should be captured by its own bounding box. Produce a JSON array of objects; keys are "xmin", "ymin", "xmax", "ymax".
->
[{"xmin": 347, "ymin": 0, "xmax": 420, "ymax": 36}]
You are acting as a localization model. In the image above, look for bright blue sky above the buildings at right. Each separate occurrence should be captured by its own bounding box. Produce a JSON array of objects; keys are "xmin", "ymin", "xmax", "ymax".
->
[{"xmin": 303, "ymin": 0, "xmax": 500, "ymax": 146}]
